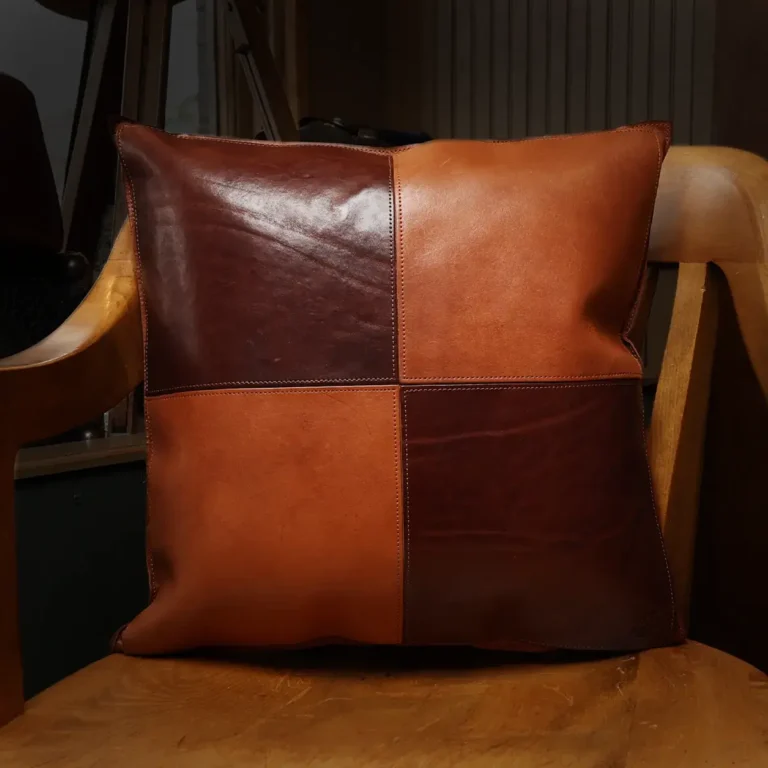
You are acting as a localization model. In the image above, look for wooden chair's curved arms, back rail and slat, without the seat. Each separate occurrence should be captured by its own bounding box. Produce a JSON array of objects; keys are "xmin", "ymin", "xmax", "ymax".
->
[{"xmin": 0, "ymin": 147, "xmax": 768, "ymax": 724}]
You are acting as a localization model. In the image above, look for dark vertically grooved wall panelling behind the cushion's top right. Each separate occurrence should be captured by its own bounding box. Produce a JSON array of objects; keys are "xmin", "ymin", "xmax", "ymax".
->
[{"xmin": 404, "ymin": 0, "xmax": 716, "ymax": 144}]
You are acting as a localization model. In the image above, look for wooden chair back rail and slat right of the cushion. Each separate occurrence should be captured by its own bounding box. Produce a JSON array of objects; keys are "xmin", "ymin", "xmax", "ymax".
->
[{"xmin": 649, "ymin": 147, "xmax": 768, "ymax": 610}]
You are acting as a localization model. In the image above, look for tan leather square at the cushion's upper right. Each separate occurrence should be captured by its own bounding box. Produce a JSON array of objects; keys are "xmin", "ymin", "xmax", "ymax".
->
[{"xmin": 393, "ymin": 124, "xmax": 666, "ymax": 382}]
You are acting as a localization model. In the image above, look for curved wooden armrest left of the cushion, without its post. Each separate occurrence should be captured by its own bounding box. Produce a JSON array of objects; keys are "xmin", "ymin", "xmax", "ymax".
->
[{"xmin": 0, "ymin": 224, "xmax": 144, "ymax": 448}]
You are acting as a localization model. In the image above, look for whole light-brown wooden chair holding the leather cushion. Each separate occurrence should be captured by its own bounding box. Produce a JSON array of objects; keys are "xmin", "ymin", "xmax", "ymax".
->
[{"xmin": 0, "ymin": 148, "xmax": 768, "ymax": 768}]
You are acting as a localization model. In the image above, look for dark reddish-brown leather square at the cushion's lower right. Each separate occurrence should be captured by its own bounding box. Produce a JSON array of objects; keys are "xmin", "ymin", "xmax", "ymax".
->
[{"xmin": 402, "ymin": 382, "xmax": 679, "ymax": 649}]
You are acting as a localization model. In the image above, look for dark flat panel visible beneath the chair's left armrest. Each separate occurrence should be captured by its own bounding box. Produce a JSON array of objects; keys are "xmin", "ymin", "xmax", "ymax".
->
[{"xmin": 16, "ymin": 462, "xmax": 148, "ymax": 700}]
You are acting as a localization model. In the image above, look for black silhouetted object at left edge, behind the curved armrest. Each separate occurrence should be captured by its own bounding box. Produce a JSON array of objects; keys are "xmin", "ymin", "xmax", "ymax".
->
[{"xmin": 0, "ymin": 73, "xmax": 91, "ymax": 358}]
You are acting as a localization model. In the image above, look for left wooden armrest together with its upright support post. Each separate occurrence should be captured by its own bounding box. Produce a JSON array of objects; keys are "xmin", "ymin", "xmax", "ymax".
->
[{"xmin": 0, "ymin": 225, "xmax": 143, "ymax": 725}]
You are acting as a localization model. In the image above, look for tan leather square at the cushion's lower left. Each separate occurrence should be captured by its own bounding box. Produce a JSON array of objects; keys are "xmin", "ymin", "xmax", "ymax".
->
[{"xmin": 118, "ymin": 386, "xmax": 402, "ymax": 654}]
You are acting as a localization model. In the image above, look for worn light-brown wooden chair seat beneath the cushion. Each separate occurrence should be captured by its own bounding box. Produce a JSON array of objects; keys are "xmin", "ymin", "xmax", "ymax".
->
[{"xmin": 0, "ymin": 642, "xmax": 768, "ymax": 768}]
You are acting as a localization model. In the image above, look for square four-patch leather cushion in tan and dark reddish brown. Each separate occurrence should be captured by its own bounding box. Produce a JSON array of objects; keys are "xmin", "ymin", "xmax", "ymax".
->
[{"xmin": 116, "ymin": 124, "xmax": 681, "ymax": 654}]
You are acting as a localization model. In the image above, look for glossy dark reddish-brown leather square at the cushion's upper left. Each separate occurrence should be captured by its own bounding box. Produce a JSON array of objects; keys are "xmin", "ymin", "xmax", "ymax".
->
[{"xmin": 118, "ymin": 125, "xmax": 396, "ymax": 392}]
